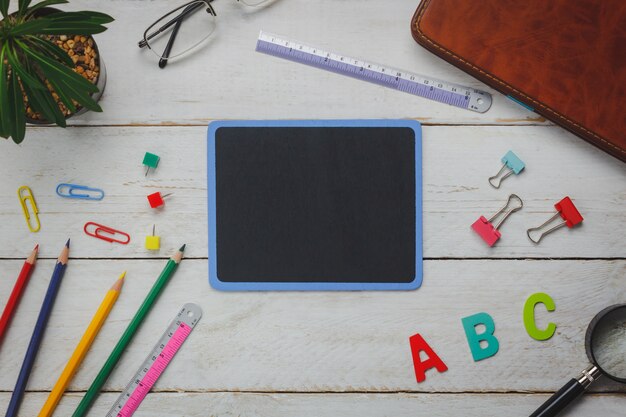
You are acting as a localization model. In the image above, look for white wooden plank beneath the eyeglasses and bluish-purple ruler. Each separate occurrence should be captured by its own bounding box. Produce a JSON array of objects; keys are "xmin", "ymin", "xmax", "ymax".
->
[{"xmin": 45, "ymin": 0, "xmax": 545, "ymax": 125}]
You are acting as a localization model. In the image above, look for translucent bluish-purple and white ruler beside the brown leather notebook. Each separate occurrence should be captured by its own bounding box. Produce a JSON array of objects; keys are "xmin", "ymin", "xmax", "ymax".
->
[{"xmin": 256, "ymin": 31, "xmax": 491, "ymax": 113}]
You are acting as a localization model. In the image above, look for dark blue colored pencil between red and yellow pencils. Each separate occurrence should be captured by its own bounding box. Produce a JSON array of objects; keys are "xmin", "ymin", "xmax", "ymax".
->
[{"xmin": 6, "ymin": 239, "xmax": 70, "ymax": 417}]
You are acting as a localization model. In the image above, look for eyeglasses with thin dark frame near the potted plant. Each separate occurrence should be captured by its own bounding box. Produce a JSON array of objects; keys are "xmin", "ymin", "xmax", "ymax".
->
[{"xmin": 138, "ymin": 0, "xmax": 270, "ymax": 68}]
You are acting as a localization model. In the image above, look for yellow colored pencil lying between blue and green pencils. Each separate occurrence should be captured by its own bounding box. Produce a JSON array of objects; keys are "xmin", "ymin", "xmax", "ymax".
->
[{"xmin": 39, "ymin": 272, "xmax": 126, "ymax": 417}]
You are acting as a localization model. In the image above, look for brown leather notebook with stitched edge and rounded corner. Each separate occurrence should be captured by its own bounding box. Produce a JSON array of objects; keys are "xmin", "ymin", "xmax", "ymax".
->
[{"xmin": 411, "ymin": 0, "xmax": 626, "ymax": 162}]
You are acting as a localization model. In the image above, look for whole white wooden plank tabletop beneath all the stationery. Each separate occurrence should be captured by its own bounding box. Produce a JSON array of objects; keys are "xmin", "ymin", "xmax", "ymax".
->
[{"xmin": 0, "ymin": 0, "xmax": 626, "ymax": 417}]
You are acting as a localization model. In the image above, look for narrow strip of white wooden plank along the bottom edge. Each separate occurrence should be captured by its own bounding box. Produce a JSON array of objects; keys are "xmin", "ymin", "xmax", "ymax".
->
[{"xmin": 0, "ymin": 393, "xmax": 626, "ymax": 417}]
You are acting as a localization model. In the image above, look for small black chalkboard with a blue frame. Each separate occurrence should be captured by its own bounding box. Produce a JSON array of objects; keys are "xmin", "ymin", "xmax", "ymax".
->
[{"xmin": 207, "ymin": 120, "xmax": 422, "ymax": 290}]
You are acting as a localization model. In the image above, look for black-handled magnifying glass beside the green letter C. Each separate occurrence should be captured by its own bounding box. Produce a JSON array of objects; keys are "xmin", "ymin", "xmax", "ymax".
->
[{"xmin": 530, "ymin": 304, "xmax": 626, "ymax": 417}]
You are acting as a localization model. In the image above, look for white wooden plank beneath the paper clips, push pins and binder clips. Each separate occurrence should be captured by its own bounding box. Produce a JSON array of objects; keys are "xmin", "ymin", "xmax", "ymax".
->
[{"xmin": 0, "ymin": 126, "xmax": 626, "ymax": 258}]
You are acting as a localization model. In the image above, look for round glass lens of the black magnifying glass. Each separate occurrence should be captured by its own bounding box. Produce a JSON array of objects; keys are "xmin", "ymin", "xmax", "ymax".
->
[{"xmin": 591, "ymin": 307, "xmax": 626, "ymax": 380}]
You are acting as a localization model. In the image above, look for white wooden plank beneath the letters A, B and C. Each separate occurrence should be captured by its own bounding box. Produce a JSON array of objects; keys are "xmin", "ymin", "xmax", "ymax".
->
[{"xmin": 0, "ymin": 259, "xmax": 626, "ymax": 392}]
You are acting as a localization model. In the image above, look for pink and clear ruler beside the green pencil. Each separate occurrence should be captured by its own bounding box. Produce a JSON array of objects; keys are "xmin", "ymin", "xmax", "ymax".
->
[{"xmin": 106, "ymin": 303, "xmax": 202, "ymax": 417}]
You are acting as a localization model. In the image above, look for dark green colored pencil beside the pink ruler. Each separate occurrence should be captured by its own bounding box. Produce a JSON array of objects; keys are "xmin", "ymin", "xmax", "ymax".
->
[{"xmin": 72, "ymin": 245, "xmax": 185, "ymax": 417}]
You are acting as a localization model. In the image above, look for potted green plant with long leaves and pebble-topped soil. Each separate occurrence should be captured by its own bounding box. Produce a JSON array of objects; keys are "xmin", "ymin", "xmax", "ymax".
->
[{"xmin": 0, "ymin": 0, "xmax": 113, "ymax": 143}]
